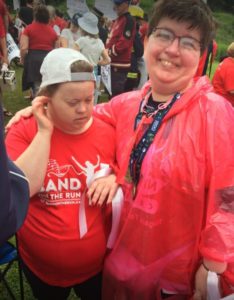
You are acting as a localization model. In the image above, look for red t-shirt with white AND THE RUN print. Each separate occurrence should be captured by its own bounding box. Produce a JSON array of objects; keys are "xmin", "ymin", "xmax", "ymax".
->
[{"xmin": 6, "ymin": 117, "xmax": 115, "ymax": 286}]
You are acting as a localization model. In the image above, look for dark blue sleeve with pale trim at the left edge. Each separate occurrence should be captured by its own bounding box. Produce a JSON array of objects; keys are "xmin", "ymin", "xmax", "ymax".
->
[{"xmin": 0, "ymin": 103, "xmax": 29, "ymax": 245}]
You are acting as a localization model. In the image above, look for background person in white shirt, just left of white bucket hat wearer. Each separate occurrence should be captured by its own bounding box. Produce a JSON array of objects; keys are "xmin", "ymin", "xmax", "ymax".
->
[{"xmin": 59, "ymin": 13, "xmax": 82, "ymax": 49}]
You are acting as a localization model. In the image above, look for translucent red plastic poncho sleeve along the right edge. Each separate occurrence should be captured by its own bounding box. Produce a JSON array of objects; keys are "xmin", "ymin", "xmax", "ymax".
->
[{"xmin": 200, "ymin": 93, "xmax": 234, "ymax": 262}]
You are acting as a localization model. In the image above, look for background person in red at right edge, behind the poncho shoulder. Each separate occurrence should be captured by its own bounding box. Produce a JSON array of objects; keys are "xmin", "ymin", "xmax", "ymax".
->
[{"xmin": 212, "ymin": 42, "xmax": 234, "ymax": 106}]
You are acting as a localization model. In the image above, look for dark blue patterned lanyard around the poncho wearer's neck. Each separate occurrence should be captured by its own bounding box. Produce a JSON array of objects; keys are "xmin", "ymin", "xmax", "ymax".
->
[{"xmin": 129, "ymin": 93, "xmax": 180, "ymax": 187}]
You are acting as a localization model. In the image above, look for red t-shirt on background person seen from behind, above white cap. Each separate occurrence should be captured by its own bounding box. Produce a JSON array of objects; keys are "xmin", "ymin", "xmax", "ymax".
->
[{"xmin": 22, "ymin": 22, "xmax": 58, "ymax": 51}]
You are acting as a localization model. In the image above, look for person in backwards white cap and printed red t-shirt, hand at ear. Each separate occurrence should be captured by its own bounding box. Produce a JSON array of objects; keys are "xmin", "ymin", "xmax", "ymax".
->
[{"xmin": 6, "ymin": 48, "xmax": 119, "ymax": 300}]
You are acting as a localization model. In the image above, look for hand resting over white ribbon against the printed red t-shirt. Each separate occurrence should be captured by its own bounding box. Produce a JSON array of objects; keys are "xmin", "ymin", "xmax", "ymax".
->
[{"xmin": 87, "ymin": 174, "xmax": 118, "ymax": 206}]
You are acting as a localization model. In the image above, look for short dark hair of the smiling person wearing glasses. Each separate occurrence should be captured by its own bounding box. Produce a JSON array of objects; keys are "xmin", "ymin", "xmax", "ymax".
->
[{"xmin": 147, "ymin": 0, "xmax": 215, "ymax": 53}]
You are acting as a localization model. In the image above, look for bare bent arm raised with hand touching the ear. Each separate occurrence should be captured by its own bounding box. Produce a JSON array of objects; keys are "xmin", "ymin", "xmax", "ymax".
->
[{"xmin": 8, "ymin": 96, "xmax": 53, "ymax": 196}]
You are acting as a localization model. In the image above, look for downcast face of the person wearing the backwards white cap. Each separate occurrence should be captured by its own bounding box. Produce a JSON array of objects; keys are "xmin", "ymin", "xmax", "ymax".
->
[{"xmin": 48, "ymin": 81, "xmax": 94, "ymax": 134}]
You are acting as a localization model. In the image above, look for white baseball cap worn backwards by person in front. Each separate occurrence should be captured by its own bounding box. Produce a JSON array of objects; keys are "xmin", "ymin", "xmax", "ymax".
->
[{"xmin": 40, "ymin": 48, "xmax": 95, "ymax": 89}]
